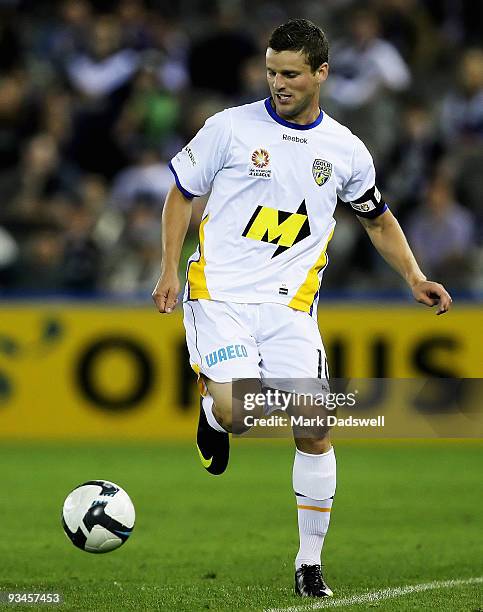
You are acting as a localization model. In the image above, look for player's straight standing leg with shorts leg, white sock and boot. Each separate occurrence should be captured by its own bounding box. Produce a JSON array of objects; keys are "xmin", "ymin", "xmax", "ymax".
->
[{"xmin": 257, "ymin": 304, "xmax": 336, "ymax": 597}]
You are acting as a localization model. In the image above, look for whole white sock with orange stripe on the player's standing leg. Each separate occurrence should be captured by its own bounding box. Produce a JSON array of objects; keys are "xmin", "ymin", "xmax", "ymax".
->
[{"xmin": 293, "ymin": 448, "xmax": 336, "ymax": 569}]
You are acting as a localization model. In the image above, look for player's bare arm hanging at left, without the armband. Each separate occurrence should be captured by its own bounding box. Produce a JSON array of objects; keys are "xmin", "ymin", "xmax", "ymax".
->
[{"xmin": 152, "ymin": 185, "xmax": 193, "ymax": 314}]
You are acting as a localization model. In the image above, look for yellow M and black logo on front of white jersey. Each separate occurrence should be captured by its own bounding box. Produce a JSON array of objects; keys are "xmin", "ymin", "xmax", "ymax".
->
[{"xmin": 242, "ymin": 200, "xmax": 310, "ymax": 257}]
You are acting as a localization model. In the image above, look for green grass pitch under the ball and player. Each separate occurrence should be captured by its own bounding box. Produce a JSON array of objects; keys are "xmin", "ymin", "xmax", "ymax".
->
[{"xmin": 0, "ymin": 440, "xmax": 483, "ymax": 611}]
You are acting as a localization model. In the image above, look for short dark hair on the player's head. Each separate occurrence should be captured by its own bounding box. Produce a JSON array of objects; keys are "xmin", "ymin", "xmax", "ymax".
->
[{"xmin": 268, "ymin": 19, "xmax": 329, "ymax": 72}]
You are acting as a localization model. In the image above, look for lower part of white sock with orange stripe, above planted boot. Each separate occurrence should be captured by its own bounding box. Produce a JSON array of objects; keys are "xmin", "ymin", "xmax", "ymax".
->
[{"xmin": 295, "ymin": 495, "xmax": 332, "ymax": 570}]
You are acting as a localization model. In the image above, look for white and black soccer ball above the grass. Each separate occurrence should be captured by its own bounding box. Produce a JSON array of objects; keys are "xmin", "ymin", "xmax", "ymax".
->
[{"xmin": 62, "ymin": 480, "xmax": 136, "ymax": 553}]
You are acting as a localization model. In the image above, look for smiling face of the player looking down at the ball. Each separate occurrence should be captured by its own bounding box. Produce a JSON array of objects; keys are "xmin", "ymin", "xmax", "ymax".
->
[{"xmin": 266, "ymin": 47, "xmax": 329, "ymax": 123}]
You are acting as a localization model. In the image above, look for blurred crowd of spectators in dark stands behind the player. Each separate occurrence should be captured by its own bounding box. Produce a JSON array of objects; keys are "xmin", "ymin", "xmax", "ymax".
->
[{"xmin": 0, "ymin": 0, "xmax": 483, "ymax": 295}]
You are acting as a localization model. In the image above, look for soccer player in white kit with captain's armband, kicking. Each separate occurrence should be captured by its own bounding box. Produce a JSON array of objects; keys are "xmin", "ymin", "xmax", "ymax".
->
[{"xmin": 153, "ymin": 19, "xmax": 451, "ymax": 597}]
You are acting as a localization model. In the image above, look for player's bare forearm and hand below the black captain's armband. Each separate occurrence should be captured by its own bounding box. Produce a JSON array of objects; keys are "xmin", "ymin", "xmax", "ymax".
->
[{"xmin": 357, "ymin": 209, "xmax": 452, "ymax": 315}]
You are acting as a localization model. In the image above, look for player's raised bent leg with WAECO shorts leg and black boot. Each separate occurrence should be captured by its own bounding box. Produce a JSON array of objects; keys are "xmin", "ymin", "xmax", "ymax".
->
[{"xmin": 184, "ymin": 300, "xmax": 260, "ymax": 474}]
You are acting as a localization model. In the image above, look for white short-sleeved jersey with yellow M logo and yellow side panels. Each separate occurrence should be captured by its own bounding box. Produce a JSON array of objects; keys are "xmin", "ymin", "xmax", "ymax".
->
[{"xmin": 170, "ymin": 98, "xmax": 386, "ymax": 313}]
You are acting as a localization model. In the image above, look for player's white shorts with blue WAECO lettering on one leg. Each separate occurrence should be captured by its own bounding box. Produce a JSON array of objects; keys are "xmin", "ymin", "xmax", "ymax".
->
[{"xmin": 183, "ymin": 300, "xmax": 329, "ymax": 393}]
